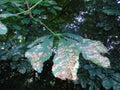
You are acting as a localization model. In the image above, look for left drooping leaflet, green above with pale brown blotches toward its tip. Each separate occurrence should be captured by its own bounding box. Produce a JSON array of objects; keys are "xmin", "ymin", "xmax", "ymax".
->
[{"xmin": 25, "ymin": 35, "xmax": 53, "ymax": 73}]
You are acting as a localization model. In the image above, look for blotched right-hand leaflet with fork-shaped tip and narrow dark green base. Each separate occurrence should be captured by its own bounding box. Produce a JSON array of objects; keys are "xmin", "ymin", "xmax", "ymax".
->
[{"xmin": 64, "ymin": 33, "xmax": 110, "ymax": 67}]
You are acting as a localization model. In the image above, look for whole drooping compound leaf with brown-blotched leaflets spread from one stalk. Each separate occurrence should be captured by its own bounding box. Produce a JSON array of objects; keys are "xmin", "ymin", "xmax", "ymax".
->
[{"xmin": 25, "ymin": 34, "xmax": 110, "ymax": 80}]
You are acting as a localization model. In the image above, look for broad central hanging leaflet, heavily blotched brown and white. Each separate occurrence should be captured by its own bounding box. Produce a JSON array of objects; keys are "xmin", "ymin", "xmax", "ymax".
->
[{"xmin": 52, "ymin": 39, "xmax": 79, "ymax": 80}]
